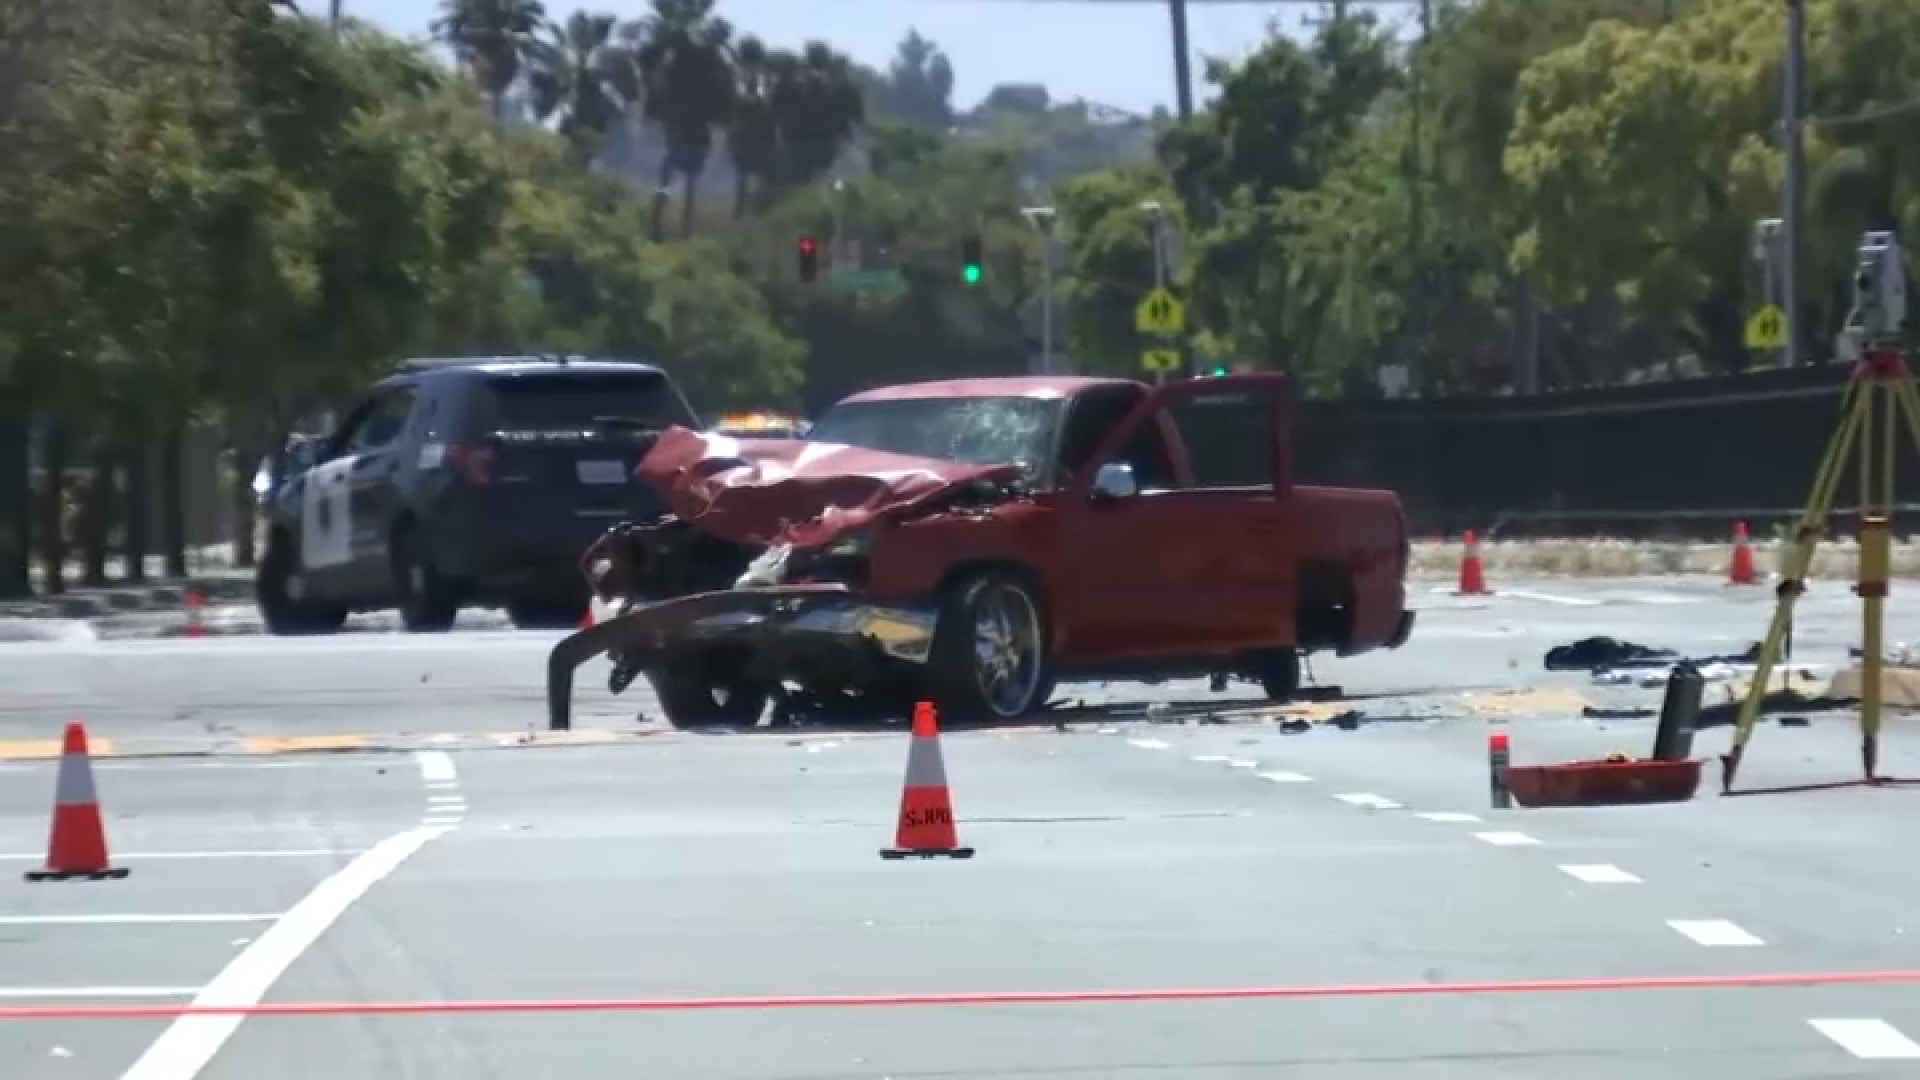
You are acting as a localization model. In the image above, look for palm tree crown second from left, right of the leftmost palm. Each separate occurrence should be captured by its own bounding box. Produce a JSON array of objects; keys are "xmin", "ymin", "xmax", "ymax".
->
[{"xmin": 528, "ymin": 12, "xmax": 639, "ymax": 160}]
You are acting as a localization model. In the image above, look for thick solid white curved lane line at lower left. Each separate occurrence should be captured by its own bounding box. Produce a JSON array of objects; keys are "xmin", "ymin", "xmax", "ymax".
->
[{"xmin": 121, "ymin": 828, "xmax": 445, "ymax": 1080}]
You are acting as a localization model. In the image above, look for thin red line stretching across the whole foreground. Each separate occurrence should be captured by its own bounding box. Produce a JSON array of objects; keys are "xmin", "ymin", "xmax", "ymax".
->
[{"xmin": 0, "ymin": 970, "xmax": 1920, "ymax": 1020}]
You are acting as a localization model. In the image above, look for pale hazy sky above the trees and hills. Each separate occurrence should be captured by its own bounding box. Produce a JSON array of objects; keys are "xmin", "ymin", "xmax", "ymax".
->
[{"xmin": 349, "ymin": 0, "xmax": 1428, "ymax": 113}]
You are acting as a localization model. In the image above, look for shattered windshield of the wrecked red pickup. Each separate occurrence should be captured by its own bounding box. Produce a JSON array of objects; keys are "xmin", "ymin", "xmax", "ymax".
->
[{"xmin": 806, "ymin": 390, "xmax": 1060, "ymax": 471}]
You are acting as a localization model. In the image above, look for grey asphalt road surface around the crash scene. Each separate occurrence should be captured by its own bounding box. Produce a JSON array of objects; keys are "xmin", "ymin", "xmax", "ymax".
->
[{"xmin": 0, "ymin": 582, "xmax": 1920, "ymax": 1080}]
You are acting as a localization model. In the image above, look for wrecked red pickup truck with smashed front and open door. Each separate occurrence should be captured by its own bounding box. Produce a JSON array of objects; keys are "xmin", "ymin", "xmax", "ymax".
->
[{"xmin": 549, "ymin": 375, "xmax": 1413, "ymax": 728}]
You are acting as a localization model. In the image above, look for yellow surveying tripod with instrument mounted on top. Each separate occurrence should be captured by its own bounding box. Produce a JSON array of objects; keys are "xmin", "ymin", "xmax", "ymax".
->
[{"xmin": 1720, "ymin": 233, "xmax": 1920, "ymax": 796}]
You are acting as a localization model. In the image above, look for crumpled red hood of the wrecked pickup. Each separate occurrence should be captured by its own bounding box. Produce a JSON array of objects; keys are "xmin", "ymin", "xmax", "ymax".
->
[{"xmin": 634, "ymin": 427, "xmax": 1021, "ymax": 548}]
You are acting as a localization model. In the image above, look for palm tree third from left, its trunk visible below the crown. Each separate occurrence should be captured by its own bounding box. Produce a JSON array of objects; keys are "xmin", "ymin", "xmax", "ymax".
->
[{"xmin": 622, "ymin": 0, "xmax": 733, "ymax": 236}]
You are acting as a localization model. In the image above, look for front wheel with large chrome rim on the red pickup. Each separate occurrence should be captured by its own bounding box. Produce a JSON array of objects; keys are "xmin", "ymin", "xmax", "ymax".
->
[{"xmin": 927, "ymin": 571, "xmax": 1054, "ymax": 721}]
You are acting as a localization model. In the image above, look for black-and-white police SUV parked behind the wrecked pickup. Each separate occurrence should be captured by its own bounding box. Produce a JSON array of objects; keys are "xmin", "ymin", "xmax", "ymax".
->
[{"xmin": 255, "ymin": 356, "xmax": 699, "ymax": 634}]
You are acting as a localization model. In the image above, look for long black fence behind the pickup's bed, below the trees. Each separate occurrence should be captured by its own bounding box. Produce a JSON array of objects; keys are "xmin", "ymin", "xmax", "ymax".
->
[{"xmin": 1294, "ymin": 363, "xmax": 1920, "ymax": 536}]
